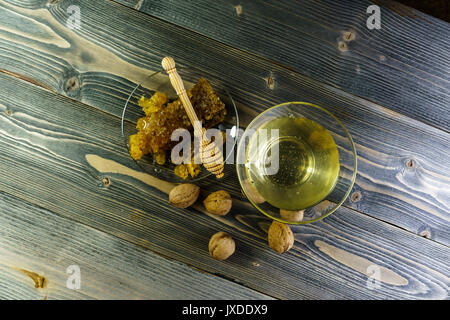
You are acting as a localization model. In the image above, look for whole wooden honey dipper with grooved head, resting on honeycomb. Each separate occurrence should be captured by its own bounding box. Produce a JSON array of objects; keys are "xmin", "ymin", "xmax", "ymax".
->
[{"xmin": 161, "ymin": 57, "xmax": 223, "ymax": 178}]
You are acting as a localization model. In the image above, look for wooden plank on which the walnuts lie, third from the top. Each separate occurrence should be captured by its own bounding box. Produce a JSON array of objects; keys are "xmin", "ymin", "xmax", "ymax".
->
[{"xmin": 0, "ymin": 74, "xmax": 450, "ymax": 299}]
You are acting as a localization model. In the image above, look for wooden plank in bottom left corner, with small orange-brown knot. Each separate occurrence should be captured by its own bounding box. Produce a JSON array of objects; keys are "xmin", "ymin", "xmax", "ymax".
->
[{"xmin": 0, "ymin": 193, "xmax": 271, "ymax": 300}]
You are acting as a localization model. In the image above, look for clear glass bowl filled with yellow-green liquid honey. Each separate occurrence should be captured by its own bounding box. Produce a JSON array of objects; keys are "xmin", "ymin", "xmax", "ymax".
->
[{"xmin": 236, "ymin": 102, "xmax": 357, "ymax": 224}]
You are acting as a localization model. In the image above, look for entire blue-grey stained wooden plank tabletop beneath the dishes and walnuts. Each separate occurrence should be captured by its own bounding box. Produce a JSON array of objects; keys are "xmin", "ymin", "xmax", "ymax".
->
[{"xmin": 0, "ymin": 0, "xmax": 450, "ymax": 299}]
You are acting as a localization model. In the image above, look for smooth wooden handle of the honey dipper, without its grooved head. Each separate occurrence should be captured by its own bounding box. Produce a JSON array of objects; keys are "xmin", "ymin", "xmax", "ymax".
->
[{"xmin": 161, "ymin": 57, "xmax": 203, "ymax": 137}]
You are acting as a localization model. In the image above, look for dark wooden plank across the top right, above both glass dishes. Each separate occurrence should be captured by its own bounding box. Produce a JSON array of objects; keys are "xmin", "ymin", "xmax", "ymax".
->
[{"xmin": 117, "ymin": 0, "xmax": 450, "ymax": 131}]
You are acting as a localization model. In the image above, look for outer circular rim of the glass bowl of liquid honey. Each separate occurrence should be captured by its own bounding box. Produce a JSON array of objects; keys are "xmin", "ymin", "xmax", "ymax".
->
[{"xmin": 236, "ymin": 101, "xmax": 358, "ymax": 225}]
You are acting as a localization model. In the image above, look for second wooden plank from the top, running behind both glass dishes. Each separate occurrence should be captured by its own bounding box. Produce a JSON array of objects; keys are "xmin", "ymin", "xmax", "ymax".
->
[{"xmin": 0, "ymin": 1, "xmax": 450, "ymax": 245}]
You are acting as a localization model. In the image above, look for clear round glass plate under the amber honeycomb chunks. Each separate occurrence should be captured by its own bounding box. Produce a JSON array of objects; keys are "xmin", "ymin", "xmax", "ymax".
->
[{"xmin": 121, "ymin": 66, "xmax": 239, "ymax": 183}]
